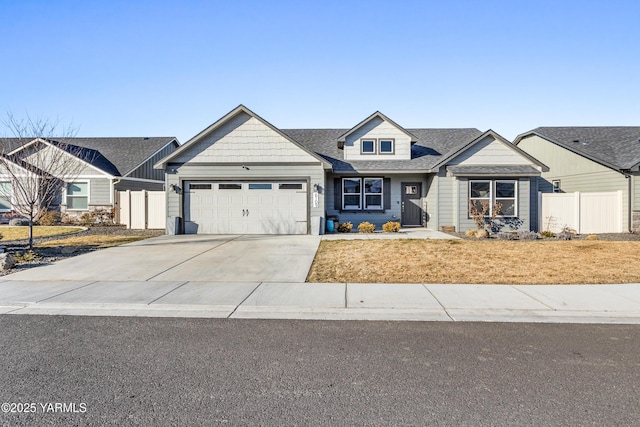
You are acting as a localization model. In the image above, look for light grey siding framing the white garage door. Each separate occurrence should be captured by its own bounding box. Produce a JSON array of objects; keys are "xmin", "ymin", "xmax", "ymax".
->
[{"xmin": 166, "ymin": 164, "xmax": 326, "ymax": 229}]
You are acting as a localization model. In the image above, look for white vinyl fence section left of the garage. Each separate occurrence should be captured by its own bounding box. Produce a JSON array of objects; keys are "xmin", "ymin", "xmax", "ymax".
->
[{"xmin": 115, "ymin": 190, "xmax": 167, "ymax": 229}]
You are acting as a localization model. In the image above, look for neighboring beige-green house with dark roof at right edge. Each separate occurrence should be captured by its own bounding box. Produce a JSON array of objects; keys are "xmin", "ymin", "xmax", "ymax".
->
[{"xmin": 514, "ymin": 127, "xmax": 640, "ymax": 231}]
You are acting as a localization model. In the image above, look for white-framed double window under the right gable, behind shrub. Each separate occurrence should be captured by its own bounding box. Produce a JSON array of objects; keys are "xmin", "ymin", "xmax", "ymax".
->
[{"xmin": 469, "ymin": 181, "xmax": 518, "ymax": 217}]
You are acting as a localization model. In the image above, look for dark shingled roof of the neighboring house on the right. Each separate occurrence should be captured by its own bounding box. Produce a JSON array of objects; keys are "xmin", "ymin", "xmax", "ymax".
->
[{"xmin": 514, "ymin": 126, "xmax": 640, "ymax": 170}]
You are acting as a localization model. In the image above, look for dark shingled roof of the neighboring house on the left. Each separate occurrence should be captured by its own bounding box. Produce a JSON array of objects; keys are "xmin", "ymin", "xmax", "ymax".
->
[{"xmin": 0, "ymin": 137, "xmax": 178, "ymax": 176}]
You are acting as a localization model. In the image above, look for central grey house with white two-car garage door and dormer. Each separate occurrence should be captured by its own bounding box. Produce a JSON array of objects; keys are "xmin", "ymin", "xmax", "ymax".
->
[{"xmin": 156, "ymin": 105, "xmax": 546, "ymax": 234}]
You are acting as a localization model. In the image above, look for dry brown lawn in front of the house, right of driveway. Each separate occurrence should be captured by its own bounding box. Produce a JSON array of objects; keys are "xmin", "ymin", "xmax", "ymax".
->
[{"xmin": 307, "ymin": 239, "xmax": 640, "ymax": 284}]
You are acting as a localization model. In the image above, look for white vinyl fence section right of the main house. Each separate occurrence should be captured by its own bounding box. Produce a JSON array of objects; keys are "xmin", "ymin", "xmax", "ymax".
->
[{"xmin": 538, "ymin": 191, "xmax": 624, "ymax": 234}]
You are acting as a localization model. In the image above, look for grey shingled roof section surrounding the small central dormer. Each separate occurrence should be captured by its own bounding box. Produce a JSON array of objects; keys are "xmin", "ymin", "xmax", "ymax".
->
[{"xmin": 282, "ymin": 128, "xmax": 482, "ymax": 173}]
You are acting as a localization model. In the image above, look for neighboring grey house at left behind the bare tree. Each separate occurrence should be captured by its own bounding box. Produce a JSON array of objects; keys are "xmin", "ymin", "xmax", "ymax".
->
[{"xmin": 0, "ymin": 137, "xmax": 179, "ymax": 216}]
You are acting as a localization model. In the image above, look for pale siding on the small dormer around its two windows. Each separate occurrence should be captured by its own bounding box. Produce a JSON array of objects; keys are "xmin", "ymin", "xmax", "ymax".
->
[{"xmin": 344, "ymin": 117, "xmax": 411, "ymax": 160}]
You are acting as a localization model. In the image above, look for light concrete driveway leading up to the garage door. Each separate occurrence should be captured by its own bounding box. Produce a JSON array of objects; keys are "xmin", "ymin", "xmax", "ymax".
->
[{"xmin": 5, "ymin": 235, "xmax": 320, "ymax": 283}]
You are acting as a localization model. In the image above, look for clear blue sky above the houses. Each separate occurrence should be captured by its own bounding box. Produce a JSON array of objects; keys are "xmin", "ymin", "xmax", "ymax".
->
[{"xmin": 0, "ymin": 0, "xmax": 640, "ymax": 143}]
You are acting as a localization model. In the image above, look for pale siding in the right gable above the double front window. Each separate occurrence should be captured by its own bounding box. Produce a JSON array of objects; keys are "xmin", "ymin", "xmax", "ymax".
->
[{"xmin": 448, "ymin": 135, "xmax": 531, "ymax": 165}]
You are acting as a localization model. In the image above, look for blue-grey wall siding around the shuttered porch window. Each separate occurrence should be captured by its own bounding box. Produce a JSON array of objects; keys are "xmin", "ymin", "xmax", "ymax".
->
[{"xmin": 325, "ymin": 173, "xmax": 426, "ymax": 230}]
